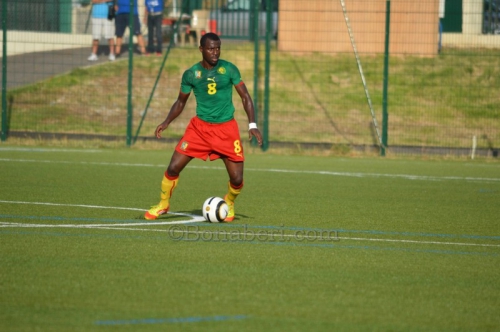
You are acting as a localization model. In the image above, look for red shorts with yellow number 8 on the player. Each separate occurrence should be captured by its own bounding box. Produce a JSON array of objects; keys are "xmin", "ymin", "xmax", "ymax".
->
[{"xmin": 175, "ymin": 116, "xmax": 245, "ymax": 162}]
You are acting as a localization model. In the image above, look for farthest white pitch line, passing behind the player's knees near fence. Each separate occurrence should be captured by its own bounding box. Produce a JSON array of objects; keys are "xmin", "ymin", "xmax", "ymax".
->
[{"xmin": 0, "ymin": 158, "xmax": 500, "ymax": 183}]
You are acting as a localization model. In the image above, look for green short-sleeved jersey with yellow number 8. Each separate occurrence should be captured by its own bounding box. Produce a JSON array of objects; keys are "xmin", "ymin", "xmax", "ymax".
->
[{"xmin": 181, "ymin": 59, "xmax": 241, "ymax": 123}]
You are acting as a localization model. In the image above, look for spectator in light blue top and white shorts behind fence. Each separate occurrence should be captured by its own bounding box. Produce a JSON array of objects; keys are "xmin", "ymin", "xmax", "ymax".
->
[{"xmin": 88, "ymin": 0, "xmax": 115, "ymax": 61}]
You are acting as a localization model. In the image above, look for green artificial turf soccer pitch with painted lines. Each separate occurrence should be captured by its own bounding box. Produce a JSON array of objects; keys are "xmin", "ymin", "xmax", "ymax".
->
[{"xmin": 0, "ymin": 148, "xmax": 500, "ymax": 331}]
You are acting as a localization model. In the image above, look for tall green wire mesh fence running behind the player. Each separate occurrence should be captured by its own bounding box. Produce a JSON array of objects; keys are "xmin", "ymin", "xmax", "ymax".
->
[{"xmin": 1, "ymin": 0, "xmax": 500, "ymax": 156}]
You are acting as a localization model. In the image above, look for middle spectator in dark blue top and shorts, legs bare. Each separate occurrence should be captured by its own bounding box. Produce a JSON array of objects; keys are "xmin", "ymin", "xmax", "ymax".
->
[{"xmin": 115, "ymin": 0, "xmax": 146, "ymax": 56}]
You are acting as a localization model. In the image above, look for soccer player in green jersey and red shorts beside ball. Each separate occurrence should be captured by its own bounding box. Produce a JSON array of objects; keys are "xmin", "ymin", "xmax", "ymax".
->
[{"xmin": 144, "ymin": 33, "xmax": 262, "ymax": 222}]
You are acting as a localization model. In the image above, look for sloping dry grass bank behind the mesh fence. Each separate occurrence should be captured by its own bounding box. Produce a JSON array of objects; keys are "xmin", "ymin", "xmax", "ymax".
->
[{"xmin": 8, "ymin": 43, "xmax": 500, "ymax": 149}]
